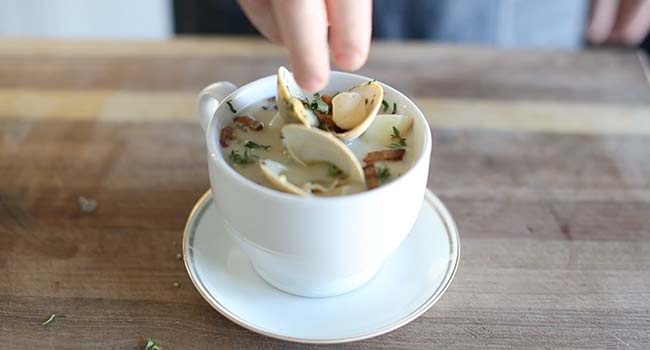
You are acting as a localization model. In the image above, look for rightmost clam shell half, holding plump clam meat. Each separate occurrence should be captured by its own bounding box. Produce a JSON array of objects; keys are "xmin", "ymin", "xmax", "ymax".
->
[{"xmin": 332, "ymin": 81, "xmax": 384, "ymax": 142}]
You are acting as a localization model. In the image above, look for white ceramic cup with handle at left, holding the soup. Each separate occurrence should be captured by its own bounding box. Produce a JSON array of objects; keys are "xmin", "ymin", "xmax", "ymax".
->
[{"xmin": 198, "ymin": 72, "xmax": 431, "ymax": 297}]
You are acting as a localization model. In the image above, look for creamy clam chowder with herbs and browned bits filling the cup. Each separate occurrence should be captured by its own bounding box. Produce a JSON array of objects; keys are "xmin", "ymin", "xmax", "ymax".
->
[{"xmin": 219, "ymin": 72, "xmax": 415, "ymax": 196}]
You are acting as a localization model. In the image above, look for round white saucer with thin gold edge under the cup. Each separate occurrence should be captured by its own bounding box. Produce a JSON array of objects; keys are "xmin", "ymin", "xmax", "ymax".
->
[{"xmin": 183, "ymin": 191, "xmax": 460, "ymax": 344}]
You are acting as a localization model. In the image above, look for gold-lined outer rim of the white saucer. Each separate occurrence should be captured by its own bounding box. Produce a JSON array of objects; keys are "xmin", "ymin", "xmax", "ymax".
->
[{"xmin": 183, "ymin": 189, "xmax": 460, "ymax": 344}]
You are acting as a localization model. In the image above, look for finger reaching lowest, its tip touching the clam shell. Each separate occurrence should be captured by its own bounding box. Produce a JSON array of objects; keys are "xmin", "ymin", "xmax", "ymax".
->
[{"xmin": 273, "ymin": 0, "xmax": 329, "ymax": 92}]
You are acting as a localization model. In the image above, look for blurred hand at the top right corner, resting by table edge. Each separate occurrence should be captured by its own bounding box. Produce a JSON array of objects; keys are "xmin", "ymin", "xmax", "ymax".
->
[{"xmin": 586, "ymin": 0, "xmax": 650, "ymax": 46}]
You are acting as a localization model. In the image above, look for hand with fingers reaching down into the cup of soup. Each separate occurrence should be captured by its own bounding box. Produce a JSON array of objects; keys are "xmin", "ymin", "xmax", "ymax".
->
[{"xmin": 238, "ymin": 0, "xmax": 372, "ymax": 92}]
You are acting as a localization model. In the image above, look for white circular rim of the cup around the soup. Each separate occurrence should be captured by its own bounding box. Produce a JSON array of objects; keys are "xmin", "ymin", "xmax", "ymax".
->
[{"xmin": 204, "ymin": 70, "xmax": 431, "ymax": 204}]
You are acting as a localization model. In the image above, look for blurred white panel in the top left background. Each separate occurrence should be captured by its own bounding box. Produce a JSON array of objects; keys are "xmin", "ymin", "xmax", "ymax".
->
[{"xmin": 0, "ymin": 0, "xmax": 173, "ymax": 39}]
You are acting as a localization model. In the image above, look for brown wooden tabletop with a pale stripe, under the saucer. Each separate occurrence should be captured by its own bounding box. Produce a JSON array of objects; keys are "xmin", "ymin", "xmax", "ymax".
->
[{"xmin": 0, "ymin": 39, "xmax": 650, "ymax": 350}]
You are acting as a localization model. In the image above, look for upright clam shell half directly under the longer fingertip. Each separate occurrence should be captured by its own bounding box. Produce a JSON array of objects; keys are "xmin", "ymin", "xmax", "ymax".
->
[{"xmin": 276, "ymin": 67, "xmax": 318, "ymax": 127}]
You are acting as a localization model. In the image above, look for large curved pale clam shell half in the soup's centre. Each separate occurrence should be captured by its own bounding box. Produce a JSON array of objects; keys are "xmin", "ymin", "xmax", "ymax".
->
[{"xmin": 282, "ymin": 124, "xmax": 365, "ymax": 184}]
